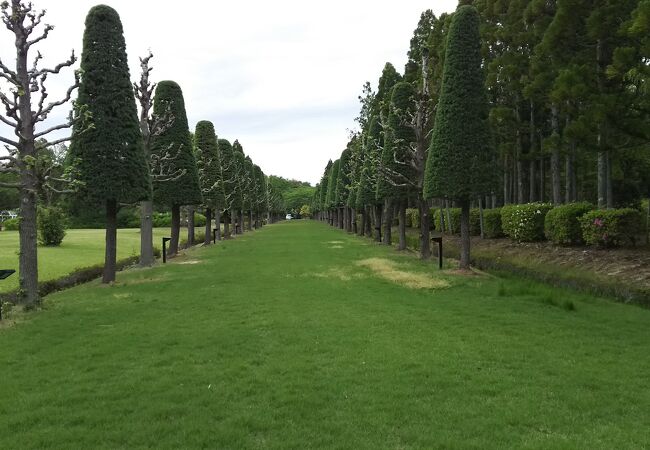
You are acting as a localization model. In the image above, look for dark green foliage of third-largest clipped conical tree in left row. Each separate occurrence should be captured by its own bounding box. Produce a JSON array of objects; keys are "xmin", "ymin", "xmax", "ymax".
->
[{"xmin": 194, "ymin": 120, "xmax": 223, "ymax": 207}]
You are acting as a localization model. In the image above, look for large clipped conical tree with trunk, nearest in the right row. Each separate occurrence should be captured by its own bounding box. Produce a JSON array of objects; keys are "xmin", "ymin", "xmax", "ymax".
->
[{"xmin": 424, "ymin": 5, "xmax": 495, "ymax": 269}]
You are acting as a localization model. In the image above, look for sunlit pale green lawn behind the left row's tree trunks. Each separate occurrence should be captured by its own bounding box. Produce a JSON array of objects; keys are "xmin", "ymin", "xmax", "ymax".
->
[{"xmin": 0, "ymin": 228, "xmax": 202, "ymax": 292}]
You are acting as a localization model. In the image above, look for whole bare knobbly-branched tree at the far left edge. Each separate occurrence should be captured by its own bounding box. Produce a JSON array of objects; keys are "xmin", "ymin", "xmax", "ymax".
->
[{"xmin": 0, "ymin": 0, "xmax": 79, "ymax": 307}]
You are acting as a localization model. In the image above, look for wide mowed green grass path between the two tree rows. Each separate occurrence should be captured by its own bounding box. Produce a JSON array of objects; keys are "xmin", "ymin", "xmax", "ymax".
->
[{"xmin": 0, "ymin": 221, "xmax": 650, "ymax": 449}]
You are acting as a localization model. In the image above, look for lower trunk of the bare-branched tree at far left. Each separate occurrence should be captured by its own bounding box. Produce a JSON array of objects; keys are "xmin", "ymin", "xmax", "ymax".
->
[{"xmin": 18, "ymin": 183, "xmax": 40, "ymax": 309}]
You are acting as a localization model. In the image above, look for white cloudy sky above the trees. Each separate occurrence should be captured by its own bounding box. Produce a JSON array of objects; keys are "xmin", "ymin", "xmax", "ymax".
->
[{"xmin": 0, "ymin": 0, "xmax": 457, "ymax": 183}]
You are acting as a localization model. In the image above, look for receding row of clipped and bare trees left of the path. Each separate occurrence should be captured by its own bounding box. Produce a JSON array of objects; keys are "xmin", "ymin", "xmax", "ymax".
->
[{"xmin": 0, "ymin": 0, "xmax": 275, "ymax": 306}]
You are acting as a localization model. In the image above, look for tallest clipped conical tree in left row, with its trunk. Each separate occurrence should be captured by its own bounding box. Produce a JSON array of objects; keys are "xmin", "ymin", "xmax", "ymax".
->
[{"xmin": 70, "ymin": 5, "xmax": 151, "ymax": 283}]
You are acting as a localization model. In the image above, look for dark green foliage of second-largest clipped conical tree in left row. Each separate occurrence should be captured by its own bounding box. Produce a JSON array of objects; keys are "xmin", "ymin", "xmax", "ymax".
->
[{"xmin": 151, "ymin": 81, "xmax": 202, "ymax": 206}]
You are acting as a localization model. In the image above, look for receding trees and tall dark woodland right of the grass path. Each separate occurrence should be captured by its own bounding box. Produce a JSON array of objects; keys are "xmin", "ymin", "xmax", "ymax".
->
[{"xmin": 311, "ymin": 0, "xmax": 650, "ymax": 267}]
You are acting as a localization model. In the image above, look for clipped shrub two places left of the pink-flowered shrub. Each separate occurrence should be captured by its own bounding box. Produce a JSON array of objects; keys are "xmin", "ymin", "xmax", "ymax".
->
[{"xmin": 501, "ymin": 203, "xmax": 553, "ymax": 242}]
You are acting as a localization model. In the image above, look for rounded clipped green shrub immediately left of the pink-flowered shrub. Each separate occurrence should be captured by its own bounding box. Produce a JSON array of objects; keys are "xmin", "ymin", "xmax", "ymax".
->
[{"xmin": 544, "ymin": 202, "xmax": 594, "ymax": 245}]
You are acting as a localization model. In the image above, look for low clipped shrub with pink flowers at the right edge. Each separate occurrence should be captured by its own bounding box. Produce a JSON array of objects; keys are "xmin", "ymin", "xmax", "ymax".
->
[{"xmin": 580, "ymin": 208, "xmax": 644, "ymax": 247}]
